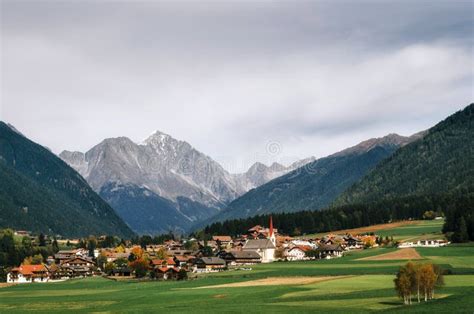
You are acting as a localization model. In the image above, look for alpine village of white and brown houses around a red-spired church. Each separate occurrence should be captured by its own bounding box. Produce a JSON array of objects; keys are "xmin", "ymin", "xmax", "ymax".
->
[{"xmin": 7, "ymin": 217, "xmax": 449, "ymax": 283}]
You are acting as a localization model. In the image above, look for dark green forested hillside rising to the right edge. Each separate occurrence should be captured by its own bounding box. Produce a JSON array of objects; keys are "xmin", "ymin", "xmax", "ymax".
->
[{"xmin": 334, "ymin": 104, "xmax": 474, "ymax": 205}]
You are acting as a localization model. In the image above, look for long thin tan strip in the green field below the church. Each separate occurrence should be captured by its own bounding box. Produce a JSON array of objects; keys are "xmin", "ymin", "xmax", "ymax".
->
[{"xmin": 193, "ymin": 276, "xmax": 350, "ymax": 289}]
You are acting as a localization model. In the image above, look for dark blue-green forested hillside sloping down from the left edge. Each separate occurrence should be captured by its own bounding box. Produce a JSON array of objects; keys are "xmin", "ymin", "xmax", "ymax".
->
[{"xmin": 0, "ymin": 122, "xmax": 133, "ymax": 237}]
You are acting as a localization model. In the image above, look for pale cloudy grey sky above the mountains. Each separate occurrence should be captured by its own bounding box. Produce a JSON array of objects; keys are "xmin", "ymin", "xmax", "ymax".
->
[{"xmin": 0, "ymin": 0, "xmax": 474, "ymax": 173}]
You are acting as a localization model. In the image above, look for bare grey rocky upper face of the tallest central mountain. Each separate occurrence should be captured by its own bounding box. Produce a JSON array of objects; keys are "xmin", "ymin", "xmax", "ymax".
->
[{"xmin": 60, "ymin": 132, "xmax": 245, "ymax": 207}]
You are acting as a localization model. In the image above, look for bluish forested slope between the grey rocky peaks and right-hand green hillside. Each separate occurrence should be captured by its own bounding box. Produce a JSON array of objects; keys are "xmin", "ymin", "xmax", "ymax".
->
[{"xmin": 201, "ymin": 134, "xmax": 420, "ymax": 222}]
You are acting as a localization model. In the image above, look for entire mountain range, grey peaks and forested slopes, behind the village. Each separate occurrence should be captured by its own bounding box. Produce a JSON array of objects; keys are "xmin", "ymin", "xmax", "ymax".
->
[{"xmin": 0, "ymin": 104, "xmax": 474, "ymax": 237}]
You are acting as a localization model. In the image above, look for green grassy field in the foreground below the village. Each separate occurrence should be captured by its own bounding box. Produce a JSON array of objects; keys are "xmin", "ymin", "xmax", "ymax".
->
[{"xmin": 0, "ymin": 222, "xmax": 474, "ymax": 313}]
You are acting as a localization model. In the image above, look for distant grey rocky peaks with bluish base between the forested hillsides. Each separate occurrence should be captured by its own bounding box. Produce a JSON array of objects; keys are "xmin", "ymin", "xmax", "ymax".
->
[{"xmin": 59, "ymin": 131, "xmax": 314, "ymax": 234}]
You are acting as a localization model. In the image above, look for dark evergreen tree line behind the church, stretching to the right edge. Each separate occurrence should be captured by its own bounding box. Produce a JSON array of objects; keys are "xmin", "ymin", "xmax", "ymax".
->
[{"xmin": 201, "ymin": 193, "xmax": 474, "ymax": 242}]
